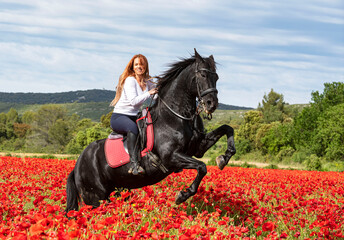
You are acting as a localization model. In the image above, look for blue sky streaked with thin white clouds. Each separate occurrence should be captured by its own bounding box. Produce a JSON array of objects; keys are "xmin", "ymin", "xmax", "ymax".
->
[{"xmin": 0, "ymin": 0, "xmax": 344, "ymax": 108}]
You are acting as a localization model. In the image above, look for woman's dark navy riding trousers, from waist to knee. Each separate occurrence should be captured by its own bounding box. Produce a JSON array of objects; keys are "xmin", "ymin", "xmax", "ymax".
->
[{"xmin": 110, "ymin": 113, "xmax": 139, "ymax": 135}]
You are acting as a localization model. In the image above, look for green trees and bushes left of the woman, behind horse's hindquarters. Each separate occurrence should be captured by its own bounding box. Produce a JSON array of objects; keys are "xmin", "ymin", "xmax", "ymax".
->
[{"xmin": 0, "ymin": 104, "xmax": 111, "ymax": 154}]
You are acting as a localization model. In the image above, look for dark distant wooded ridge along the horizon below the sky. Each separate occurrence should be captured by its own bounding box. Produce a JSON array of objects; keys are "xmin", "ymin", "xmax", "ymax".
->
[{"xmin": 0, "ymin": 89, "xmax": 252, "ymax": 110}]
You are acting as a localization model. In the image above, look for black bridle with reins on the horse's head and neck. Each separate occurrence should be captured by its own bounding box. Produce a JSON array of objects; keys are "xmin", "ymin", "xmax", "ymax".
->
[{"xmin": 158, "ymin": 63, "xmax": 218, "ymax": 121}]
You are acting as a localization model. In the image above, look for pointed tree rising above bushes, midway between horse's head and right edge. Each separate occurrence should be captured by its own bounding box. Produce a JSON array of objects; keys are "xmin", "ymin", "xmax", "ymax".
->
[{"xmin": 258, "ymin": 89, "xmax": 287, "ymax": 123}]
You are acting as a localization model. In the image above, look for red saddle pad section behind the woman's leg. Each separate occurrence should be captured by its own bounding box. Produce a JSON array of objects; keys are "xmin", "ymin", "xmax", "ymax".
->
[{"xmin": 104, "ymin": 138, "xmax": 130, "ymax": 168}]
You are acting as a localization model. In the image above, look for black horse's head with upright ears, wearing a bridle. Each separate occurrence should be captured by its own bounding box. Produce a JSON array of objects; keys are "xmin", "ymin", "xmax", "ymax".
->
[{"xmin": 195, "ymin": 49, "xmax": 219, "ymax": 114}]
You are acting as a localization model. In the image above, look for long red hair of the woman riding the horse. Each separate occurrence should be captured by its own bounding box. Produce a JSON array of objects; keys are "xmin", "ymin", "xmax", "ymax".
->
[{"xmin": 110, "ymin": 54, "xmax": 150, "ymax": 106}]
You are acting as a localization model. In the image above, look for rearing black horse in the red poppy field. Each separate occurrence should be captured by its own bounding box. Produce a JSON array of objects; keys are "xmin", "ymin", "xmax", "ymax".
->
[{"xmin": 66, "ymin": 49, "xmax": 235, "ymax": 212}]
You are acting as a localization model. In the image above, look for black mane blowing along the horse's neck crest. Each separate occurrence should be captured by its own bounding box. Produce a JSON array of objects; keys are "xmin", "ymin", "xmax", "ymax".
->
[{"xmin": 157, "ymin": 56, "xmax": 196, "ymax": 89}]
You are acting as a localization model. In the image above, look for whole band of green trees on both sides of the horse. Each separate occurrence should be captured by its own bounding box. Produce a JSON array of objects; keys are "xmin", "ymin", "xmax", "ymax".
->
[{"xmin": 0, "ymin": 82, "xmax": 344, "ymax": 170}]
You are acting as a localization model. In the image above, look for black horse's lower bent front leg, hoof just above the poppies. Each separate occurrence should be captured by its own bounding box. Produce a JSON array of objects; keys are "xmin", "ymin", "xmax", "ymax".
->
[{"xmin": 173, "ymin": 153, "xmax": 207, "ymax": 204}]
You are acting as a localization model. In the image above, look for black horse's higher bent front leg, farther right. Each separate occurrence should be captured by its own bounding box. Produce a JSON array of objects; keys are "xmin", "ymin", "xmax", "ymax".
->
[{"xmin": 195, "ymin": 125, "xmax": 236, "ymax": 170}]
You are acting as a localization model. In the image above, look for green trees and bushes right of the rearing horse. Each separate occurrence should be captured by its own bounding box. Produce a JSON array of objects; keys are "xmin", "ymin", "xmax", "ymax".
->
[{"xmin": 206, "ymin": 82, "xmax": 344, "ymax": 171}]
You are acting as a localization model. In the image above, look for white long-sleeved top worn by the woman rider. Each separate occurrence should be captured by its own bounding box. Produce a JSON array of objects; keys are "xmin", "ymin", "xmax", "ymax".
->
[{"xmin": 113, "ymin": 77, "xmax": 156, "ymax": 116}]
